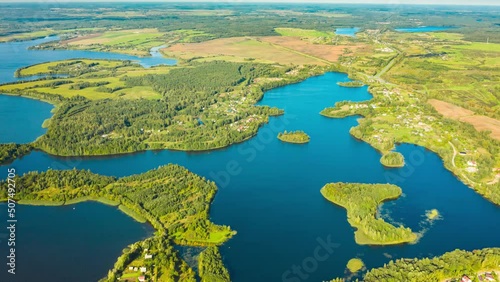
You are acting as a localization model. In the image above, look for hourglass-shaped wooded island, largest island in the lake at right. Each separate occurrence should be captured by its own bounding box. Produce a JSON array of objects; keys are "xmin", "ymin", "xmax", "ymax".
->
[{"xmin": 321, "ymin": 182, "xmax": 418, "ymax": 245}]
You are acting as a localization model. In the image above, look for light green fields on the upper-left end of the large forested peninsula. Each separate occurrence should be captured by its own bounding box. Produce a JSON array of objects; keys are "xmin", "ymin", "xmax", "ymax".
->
[{"xmin": 0, "ymin": 59, "xmax": 171, "ymax": 100}]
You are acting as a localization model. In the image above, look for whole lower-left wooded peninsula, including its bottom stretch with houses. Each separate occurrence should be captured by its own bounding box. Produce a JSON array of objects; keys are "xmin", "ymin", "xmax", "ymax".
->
[{"xmin": 0, "ymin": 165, "xmax": 235, "ymax": 281}]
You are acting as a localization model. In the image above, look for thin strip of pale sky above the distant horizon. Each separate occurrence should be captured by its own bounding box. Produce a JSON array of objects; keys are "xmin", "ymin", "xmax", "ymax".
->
[{"xmin": 0, "ymin": 0, "xmax": 500, "ymax": 6}]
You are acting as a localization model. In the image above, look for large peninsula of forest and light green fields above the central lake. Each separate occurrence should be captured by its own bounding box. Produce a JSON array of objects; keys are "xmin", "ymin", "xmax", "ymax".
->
[{"xmin": 0, "ymin": 59, "xmax": 323, "ymax": 156}]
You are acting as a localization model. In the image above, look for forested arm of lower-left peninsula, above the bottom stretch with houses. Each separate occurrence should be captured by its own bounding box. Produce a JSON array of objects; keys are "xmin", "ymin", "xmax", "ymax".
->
[{"xmin": 0, "ymin": 165, "xmax": 233, "ymax": 245}]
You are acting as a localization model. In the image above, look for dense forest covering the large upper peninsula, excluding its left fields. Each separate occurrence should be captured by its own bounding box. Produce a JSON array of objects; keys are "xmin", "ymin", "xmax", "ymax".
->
[{"xmin": 22, "ymin": 62, "xmax": 293, "ymax": 156}]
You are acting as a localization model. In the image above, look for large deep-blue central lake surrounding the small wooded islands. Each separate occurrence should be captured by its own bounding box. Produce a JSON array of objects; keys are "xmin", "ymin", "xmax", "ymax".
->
[{"xmin": 0, "ymin": 38, "xmax": 500, "ymax": 282}]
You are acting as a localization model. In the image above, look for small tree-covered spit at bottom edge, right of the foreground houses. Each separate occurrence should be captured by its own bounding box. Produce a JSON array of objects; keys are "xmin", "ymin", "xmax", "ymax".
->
[{"xmin": 198, "ymin": 247, "xmax": 231, "ymax": 282}]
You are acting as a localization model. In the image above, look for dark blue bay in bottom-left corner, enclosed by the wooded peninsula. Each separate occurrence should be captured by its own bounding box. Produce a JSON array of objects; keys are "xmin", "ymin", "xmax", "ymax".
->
[{"xmin": 0, "ymin": 202, "xmax": 153, "ymax": 282}]
